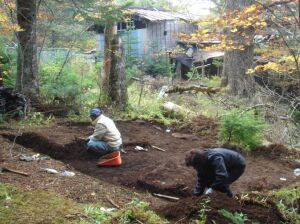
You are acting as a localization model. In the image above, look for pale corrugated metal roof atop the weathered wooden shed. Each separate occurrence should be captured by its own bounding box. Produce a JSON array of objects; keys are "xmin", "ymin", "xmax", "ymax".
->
[{"xmin": 129, "ymin": 9, "xmax": 191, "ymax": 21}]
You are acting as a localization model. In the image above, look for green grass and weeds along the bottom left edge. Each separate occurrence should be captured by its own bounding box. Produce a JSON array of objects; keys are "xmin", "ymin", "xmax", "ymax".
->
[{"xmin": 0, "ymin": 183, "xmax": 168, "ymax": 224}]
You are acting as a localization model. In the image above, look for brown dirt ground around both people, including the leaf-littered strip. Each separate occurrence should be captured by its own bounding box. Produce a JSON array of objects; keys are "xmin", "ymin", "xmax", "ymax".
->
[{"xmin": 0, "ymin": 117, "xmax": 300, "ymax": 223}]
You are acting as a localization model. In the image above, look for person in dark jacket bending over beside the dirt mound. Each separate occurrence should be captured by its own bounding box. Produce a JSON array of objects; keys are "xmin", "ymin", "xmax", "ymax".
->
[{"xmin": 185, "ymin": 148, "xmax": 246, "ymax": 197}]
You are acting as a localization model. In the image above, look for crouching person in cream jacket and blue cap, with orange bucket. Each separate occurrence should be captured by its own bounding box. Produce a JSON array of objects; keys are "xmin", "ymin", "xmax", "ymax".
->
[{"xmin": 87, "ymin": 108, "xmax": 122, "ymax": 166}]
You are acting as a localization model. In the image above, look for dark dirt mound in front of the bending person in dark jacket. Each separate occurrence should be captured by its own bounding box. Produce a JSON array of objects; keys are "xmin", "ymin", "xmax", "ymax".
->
[{"xmin": 157, "ymin": 192, "xmax": 287, "ymax": 224}]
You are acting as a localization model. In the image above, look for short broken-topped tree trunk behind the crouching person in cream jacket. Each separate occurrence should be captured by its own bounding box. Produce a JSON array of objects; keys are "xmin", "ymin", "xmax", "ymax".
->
[{"xmin": 108, "ymin": 36, "xmax": 127, "ymax": 109}]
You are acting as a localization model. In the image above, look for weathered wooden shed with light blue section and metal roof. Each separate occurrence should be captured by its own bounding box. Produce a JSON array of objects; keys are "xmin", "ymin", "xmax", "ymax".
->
[{"xmin": 94, "ymin": 8, "xmax": 196, "ymax": 60}]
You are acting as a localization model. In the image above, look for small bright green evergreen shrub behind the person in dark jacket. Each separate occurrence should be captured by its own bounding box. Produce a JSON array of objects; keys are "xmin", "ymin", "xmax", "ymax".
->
[{"xmin": 219, "ymin": 109, "xmax": 265, "ymax": 150}]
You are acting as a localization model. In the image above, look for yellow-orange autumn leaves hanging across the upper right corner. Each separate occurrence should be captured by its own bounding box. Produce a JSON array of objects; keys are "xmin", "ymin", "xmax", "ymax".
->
[{"xmin": 180, "ymin": 0, "xmax": 300, "ymax": 90}]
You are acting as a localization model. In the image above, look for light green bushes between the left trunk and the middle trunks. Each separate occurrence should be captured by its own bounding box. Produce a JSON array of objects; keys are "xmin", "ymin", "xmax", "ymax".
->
[{"xmin": 39, "ymin": 58, "xmax": 98, "ymax": 111}]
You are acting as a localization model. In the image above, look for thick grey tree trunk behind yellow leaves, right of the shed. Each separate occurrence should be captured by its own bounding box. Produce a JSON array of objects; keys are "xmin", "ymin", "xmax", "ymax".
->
[{"xmin": 221, "ymin": 0, "xmax": 255, "ymax": 96}]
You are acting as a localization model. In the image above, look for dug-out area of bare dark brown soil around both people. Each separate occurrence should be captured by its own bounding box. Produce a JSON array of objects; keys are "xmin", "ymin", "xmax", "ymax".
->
[{"xmin": 2, "ymin": 121, "xmax": 299, "ymax": 197}]
